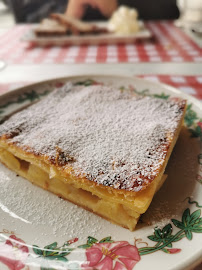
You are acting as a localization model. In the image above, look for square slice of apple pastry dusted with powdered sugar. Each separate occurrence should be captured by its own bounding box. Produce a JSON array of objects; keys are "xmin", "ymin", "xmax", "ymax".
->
[{"xmin": 0, "ymin": 83, "xmax": 186, "ymax": 230}]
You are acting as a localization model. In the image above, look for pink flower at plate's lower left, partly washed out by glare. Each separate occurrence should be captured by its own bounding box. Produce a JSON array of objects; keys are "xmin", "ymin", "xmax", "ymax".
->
[{"xmin": 0, "ymin": 235, "xmax": 29, "ymax": 270}]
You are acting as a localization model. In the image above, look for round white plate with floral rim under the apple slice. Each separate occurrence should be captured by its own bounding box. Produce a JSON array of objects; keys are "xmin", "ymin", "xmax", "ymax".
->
[{"xmin": 0, "ymin": 76, "xmax": 202, "ymax": 270}]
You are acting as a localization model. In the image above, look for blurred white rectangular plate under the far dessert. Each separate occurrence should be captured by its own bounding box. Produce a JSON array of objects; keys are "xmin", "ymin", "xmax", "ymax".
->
[{"xmin": 22, "ymin": 22, "xmax": 152, "ymax": 46}]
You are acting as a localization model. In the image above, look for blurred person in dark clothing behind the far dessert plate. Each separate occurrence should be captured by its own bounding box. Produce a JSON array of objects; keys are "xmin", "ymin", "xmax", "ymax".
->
[{"xmin": 6, "ymin": 0, "xmax": 179, "ymax": 23}]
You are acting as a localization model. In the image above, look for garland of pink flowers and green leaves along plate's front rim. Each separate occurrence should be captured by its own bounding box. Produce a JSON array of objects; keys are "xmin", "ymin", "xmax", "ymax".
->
[{"xmin": 0, "ymin": 198, "xmax": 202, "ymax": 270}]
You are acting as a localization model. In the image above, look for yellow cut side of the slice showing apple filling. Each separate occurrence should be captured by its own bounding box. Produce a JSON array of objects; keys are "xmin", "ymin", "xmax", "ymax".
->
[{"xmin": 0, "ymin": 148, "xmax": 166, "ymax": 231}]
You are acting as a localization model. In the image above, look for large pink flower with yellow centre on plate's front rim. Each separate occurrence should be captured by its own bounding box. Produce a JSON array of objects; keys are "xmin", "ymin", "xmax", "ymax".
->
[{"xmin": 82, "ymin": 241, "xmax": 140, "ymax": 270}]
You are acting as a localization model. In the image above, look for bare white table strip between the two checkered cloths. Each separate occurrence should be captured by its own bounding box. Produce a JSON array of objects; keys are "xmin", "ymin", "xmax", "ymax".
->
[{"xmin": 0, "ymin": 21, "xmax": 202, "ymax": 270}]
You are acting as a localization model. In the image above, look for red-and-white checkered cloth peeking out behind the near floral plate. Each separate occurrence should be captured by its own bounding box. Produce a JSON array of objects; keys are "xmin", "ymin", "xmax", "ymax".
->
[{"xmin": 0, "ymin": 75, "xmax": 202, "ymax": 100}]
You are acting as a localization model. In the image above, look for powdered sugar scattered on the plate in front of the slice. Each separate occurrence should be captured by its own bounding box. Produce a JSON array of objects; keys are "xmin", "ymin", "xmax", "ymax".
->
[{"xmin": 0, "ymin": 168, "xmax": 106, "ymax": 239}]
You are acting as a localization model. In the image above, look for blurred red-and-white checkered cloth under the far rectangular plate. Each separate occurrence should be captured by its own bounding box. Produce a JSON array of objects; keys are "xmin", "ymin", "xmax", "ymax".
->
[{"xmin": 0, "ymin": 21, "xmax": 202, "ymax": 64}]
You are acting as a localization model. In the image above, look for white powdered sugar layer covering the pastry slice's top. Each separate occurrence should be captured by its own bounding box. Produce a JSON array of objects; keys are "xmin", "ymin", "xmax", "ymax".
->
[{"xmin": 0, "ymin": 83, "xmax": 183, "ymax": 191}]
